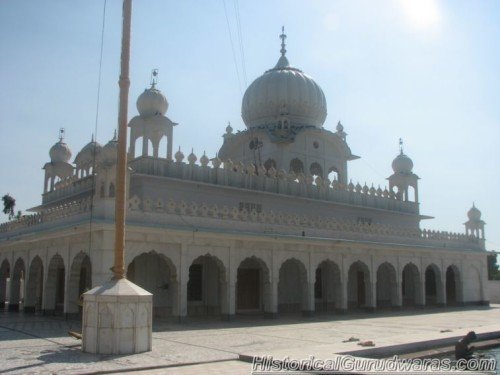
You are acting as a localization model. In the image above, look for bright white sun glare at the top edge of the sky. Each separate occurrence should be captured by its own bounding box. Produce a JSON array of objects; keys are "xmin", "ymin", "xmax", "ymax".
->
[{"xmin": 397, "ymin": 0, "xmax": 440, "ymax": 30}]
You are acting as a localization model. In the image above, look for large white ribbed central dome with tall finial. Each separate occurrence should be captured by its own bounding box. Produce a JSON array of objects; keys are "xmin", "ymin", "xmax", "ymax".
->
[{"xmin": 241, "ymin": 29, "xmax": 326, "ymax": 128}]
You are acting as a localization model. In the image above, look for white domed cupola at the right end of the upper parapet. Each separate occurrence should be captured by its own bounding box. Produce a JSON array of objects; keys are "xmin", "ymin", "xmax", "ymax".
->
[{"xmin": 388, "ymin": 138, "xmax": 419, "ymax": 203}]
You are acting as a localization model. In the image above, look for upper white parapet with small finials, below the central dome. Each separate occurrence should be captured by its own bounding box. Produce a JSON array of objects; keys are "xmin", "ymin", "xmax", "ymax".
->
[{"xmin": 129, "ymin": 154, "xmax": 419, "ymax": 214}]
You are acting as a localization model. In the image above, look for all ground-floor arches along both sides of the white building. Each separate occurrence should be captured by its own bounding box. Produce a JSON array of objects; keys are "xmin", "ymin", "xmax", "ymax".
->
[{"xmin": 0, "ymin": 251, "xmax": 474, "ymax": 317}]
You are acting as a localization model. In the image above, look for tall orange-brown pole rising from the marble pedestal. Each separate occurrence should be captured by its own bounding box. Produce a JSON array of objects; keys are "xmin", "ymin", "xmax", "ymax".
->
[{"xmin": 112, "ymin": 0, "xmax": 132, "ymax": 279}]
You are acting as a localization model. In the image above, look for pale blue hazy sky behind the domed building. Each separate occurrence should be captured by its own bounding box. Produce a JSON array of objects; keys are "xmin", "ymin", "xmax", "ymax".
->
[{"xmin": 0, "ymin": 0, "xmax": 500, "ymax": 251}]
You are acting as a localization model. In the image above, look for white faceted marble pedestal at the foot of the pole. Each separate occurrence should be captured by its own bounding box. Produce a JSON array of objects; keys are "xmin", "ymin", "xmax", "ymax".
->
[{"xmin": 82, "ymin": 279, "xmax": 153, "ymax": 354}]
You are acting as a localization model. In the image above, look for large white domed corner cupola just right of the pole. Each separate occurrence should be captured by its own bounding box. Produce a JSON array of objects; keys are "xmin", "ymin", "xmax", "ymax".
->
[{"xmin": 128, "ymin": 69, "xmax": 177, "ymax": 160}]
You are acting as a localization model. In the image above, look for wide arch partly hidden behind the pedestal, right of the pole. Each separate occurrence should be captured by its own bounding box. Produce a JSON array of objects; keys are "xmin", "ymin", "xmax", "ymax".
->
[{"xmin": 127, "ymin": 251, "xmax": 177, "ymax": 318}]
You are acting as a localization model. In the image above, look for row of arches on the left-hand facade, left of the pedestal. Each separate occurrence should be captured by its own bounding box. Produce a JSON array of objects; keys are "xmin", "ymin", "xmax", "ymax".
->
[{"xmin": 0, "ymin": 253, "xmax": 92, "ymax": 314}]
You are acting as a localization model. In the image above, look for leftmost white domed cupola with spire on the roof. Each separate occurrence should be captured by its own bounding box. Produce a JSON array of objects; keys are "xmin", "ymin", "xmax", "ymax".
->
[{"xmin": 43, "ymin": 128, "xmax": 74, "ymax": 194}]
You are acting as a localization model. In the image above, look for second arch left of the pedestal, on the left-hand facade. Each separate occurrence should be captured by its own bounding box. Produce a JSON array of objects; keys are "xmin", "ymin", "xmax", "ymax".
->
[{"xmin": 44, "ymin": 254, "xmax": 66, "ymax": 314}]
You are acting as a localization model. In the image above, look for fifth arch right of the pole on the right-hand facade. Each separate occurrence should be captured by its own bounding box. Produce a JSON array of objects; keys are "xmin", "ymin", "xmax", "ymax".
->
[{"xmin": 314, "ymin": 260, "xmax": 342, "ymax": 312}]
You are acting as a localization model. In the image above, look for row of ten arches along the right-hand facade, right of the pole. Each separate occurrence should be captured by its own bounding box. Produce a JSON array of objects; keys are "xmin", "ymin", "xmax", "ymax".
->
[{"xmin": 127, "ymin": 252, "xmax": 468, "ymax": 316}]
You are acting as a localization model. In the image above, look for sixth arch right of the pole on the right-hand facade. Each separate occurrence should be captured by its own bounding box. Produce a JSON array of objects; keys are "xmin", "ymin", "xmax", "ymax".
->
[{"xmin": 347, "ymin": 260, "xmax": 371, "ymax": 309}]
